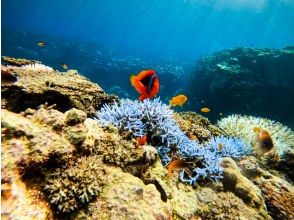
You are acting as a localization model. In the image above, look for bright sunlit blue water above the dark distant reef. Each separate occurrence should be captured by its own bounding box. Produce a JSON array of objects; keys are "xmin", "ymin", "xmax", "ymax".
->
[{"xmin": 2, "ymin": 0, "xmax": 294, "ymax": 61}]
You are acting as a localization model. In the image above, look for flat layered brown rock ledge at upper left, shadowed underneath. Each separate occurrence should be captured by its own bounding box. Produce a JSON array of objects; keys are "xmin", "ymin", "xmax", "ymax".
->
[{"xmin": 1, "ymin": 60, "xmax": 117, "ymax": 115}]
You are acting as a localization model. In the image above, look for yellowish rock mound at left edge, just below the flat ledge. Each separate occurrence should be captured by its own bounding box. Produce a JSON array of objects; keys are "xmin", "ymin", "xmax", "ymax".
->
[{"xmin": 1, "ymin": 109, "xmax": 75, "ymax": 179}]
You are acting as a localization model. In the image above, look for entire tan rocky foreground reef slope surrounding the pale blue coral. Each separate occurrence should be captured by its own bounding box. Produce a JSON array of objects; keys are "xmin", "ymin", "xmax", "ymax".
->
[{"xmin": 1, "ymin": 57, "xmax": 294, "ymax": 219}]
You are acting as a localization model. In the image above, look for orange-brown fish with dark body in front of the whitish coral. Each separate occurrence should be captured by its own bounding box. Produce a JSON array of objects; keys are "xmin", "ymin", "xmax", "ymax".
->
[{"xmin": 253, "ymin": 127, "xmax": 274, "ymax": 153}]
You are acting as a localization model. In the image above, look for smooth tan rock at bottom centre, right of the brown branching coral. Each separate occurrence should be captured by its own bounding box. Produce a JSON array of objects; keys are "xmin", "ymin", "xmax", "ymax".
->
[{"xmin": 74, "ymin": 167, "xmax": 173, "ymax": 219}]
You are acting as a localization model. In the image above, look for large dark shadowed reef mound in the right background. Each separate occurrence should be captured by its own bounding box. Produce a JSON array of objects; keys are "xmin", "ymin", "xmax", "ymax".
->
[{"xmin": 188, "ymin": 47, "xmax": 294, "ymax": 127}]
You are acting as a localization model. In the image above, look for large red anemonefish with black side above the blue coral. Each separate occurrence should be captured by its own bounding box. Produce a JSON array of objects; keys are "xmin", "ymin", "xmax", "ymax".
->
[{"xmin": 130, "ymin": 70, "xmax": 159, "ymax": 101}]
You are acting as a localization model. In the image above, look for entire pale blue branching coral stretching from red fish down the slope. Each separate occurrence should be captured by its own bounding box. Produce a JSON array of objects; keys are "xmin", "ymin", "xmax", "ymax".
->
[{"xmin": 97, "ymin": 98, "xmax": 246, "ymax": 184}]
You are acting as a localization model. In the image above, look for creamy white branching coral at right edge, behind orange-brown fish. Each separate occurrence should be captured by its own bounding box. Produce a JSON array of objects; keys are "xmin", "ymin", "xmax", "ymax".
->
[{"xmin": 217, "ymin": 115, "xmax": 294, "ymax": 156}]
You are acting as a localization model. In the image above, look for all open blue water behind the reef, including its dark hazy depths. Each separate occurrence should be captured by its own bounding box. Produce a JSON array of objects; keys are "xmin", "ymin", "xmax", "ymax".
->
[{"xmin": 1, "ymin": 0, "xmax": 294, "ymax": 124}]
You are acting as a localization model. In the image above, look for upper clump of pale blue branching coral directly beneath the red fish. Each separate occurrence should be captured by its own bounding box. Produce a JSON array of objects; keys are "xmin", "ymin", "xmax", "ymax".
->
[{"xmin": 97, "ymin": 98, "xmax": 184, "ymax": 146}]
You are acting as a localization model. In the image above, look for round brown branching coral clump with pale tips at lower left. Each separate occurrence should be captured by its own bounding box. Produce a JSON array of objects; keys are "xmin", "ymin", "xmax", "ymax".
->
[{"xmin": 44, "ymin": 157, "xmax": 105, "ymax": 213}]
